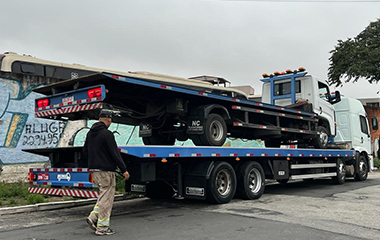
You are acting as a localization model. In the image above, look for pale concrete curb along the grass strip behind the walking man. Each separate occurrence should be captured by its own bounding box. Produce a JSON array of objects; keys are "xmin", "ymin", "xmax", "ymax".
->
[{"xmin": 0, "ymin": 194, "xmax": 134, "ymax": 216}]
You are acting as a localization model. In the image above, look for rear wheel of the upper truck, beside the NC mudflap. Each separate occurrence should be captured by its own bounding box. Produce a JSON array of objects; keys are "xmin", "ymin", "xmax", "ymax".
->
[{"xmin": 199, "ymin": 113, "xmax": 227, "ymax": 146}]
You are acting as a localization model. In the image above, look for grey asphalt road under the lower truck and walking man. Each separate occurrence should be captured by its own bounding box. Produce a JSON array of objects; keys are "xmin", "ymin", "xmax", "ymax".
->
[{"xmin": 0, "ymin": 172, "xmax": 380, "ymax": 240}]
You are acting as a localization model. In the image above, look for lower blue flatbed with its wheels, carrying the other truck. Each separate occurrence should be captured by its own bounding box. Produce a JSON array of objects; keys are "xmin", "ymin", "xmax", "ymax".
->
[{"xmin": 24, "ymin": 146, "xmax": 365, "ymax": 203}]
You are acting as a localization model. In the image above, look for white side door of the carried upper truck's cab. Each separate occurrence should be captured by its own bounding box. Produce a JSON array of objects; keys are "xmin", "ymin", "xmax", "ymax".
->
[{"xmin": 314, "ymin": 81, "xmax": 336, "ymax": 136}]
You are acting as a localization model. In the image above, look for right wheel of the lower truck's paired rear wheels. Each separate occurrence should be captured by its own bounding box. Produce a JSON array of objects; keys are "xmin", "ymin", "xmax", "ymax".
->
[{"xmin": 237, "ymin": 162, "xmax": 265, "ymax": 199}]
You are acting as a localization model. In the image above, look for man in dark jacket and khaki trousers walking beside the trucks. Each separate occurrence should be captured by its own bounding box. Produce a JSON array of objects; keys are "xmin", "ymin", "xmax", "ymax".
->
[{"xmin": 83, "ymin": 109, "xmax": 129, "ymax": 236}]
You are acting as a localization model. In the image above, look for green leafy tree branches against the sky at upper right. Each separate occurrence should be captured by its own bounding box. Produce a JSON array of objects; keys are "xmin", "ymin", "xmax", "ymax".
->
[{"xmin": 328, "ymin": 19, "xmax": 380, "ymax": 86}]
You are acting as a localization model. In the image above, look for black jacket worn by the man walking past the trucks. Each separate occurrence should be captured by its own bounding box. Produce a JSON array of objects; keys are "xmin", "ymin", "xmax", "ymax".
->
[{"xmin": 83, "ymin": 122, "xmax": 127, "ymax": 173}]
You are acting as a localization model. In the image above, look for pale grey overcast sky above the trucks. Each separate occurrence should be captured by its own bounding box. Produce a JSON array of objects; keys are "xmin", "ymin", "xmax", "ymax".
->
[{"xmin": 0, "ymin": 0, "xmax": 380, "ymax": 98}]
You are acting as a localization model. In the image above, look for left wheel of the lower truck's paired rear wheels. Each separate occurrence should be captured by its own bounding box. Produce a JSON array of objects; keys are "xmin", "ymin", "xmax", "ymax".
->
[{"xmin": 206, "ymin": 162, "xmax": 236, "ymax": 203}]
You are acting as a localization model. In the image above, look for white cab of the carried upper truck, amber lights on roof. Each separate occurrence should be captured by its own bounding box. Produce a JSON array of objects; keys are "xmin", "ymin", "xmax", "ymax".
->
[{"xmin": 261, "ymin": 68, "xmax": 340, "ymax": 148}]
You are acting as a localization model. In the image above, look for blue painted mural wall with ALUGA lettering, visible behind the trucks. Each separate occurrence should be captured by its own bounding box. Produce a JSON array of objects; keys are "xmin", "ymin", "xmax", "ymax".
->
[{"xmin": 0, "ymin": 77, "xmax": 263, "ymax": 166}]
